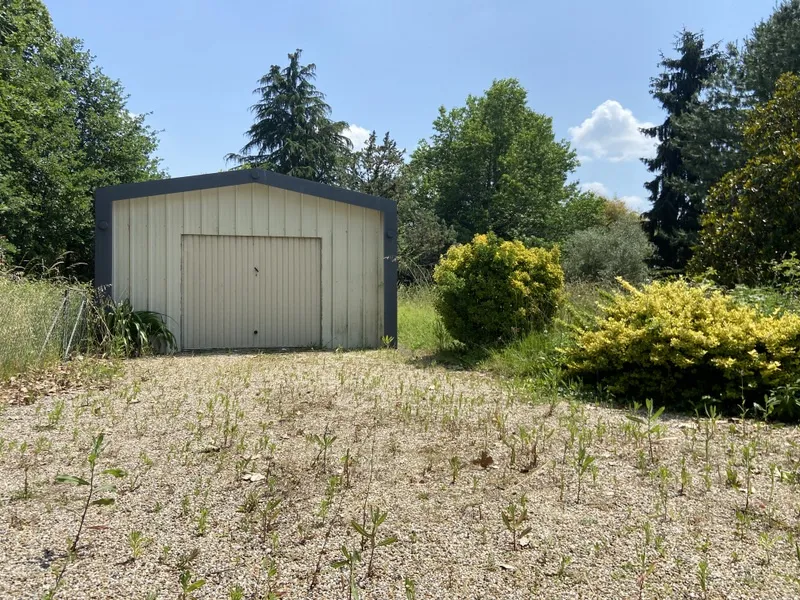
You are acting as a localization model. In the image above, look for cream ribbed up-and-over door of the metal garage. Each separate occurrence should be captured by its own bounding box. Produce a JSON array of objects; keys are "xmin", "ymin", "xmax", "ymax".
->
[{"xmin": 181, "ymin": 235, "xmax": 322, "ymax": 349}]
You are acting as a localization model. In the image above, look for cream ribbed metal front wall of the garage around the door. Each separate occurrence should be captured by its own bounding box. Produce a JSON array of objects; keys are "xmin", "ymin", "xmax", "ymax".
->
[{"xmin": 112, "ymin": 183, "xmax": 384, "ymax": 348}]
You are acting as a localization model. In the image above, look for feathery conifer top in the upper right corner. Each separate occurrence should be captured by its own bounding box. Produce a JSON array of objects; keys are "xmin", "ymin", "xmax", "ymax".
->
[{"xmin": 742, "ymin": 0, "xmax": 800, "ymax": 102}]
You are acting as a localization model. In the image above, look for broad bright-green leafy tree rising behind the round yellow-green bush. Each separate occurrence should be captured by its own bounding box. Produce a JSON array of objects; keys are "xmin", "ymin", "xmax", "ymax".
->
[{"xmin": 411, "ymin": 79, "xmax": 578, "ymax": 242}]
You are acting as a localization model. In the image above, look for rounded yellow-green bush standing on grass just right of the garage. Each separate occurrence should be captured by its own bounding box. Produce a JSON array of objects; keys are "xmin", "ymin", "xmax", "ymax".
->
[{"xmin": 433, "ymin": 233, "xmax": 564, "ymax": 345}]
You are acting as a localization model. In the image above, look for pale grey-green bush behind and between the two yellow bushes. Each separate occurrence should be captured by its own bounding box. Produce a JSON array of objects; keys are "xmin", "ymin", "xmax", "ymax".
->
[{"xmin": 563, "ymin": 214, "xmax": 654, "ymax": 283}]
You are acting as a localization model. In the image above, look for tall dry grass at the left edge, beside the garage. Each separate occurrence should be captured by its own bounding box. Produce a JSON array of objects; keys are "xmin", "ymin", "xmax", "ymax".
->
[{"xmin": 0, "ymin": 272, "xmax": 86, "ymax": 380}]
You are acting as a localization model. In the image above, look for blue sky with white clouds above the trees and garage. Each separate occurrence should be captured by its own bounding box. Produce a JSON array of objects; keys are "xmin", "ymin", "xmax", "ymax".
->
[{"xmin": 47, "ymin": 0, "xmax": 774, "ymax": 208}]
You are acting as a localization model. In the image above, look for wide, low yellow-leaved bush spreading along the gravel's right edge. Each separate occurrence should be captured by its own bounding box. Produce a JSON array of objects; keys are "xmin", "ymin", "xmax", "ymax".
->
[{"xmin": 564, "ymin": 280, "xmax": 800, "ymax": 419}]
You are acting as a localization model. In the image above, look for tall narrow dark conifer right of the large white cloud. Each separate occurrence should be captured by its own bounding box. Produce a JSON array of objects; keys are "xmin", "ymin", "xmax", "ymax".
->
[{"xmin": 642, "ymin": 30, "xmax": 721, "ymax": 268}]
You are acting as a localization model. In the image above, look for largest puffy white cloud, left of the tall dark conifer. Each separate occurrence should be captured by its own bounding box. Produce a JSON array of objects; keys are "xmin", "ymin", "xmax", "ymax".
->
[{"xmin": 569, "ymin": 100, "xmax": 656, "ymax": 162}]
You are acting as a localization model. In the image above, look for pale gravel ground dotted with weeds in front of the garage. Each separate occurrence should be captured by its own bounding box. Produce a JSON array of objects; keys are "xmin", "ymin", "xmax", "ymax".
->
[{"xmin": 0, "ymin": 351, "xmax": 800, "ymax": 599}]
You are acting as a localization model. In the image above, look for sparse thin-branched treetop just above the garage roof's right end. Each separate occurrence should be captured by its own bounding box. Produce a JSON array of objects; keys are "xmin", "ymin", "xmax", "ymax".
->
[{"xmin": 340, "ymin": 131, "xmax": 405, "ymax": 200}]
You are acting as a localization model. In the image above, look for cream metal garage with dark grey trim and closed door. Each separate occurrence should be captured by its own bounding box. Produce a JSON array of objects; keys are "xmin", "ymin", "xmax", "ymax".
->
[{"xmin": 95, "ymin": 169, "xmax": 397, "ymax": 350}]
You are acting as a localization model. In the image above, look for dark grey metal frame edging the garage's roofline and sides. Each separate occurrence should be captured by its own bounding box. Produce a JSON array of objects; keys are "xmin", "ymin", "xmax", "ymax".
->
[{"xmin": 94, "ymin": 169, "xmax": 397, "ymax": 347}]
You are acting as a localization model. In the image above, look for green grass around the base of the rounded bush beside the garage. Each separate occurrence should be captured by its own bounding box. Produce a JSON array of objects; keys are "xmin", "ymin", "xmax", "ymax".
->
[{"xmin": 398, "ymin": 284, "xmax": 604, "ymax": 377}]
